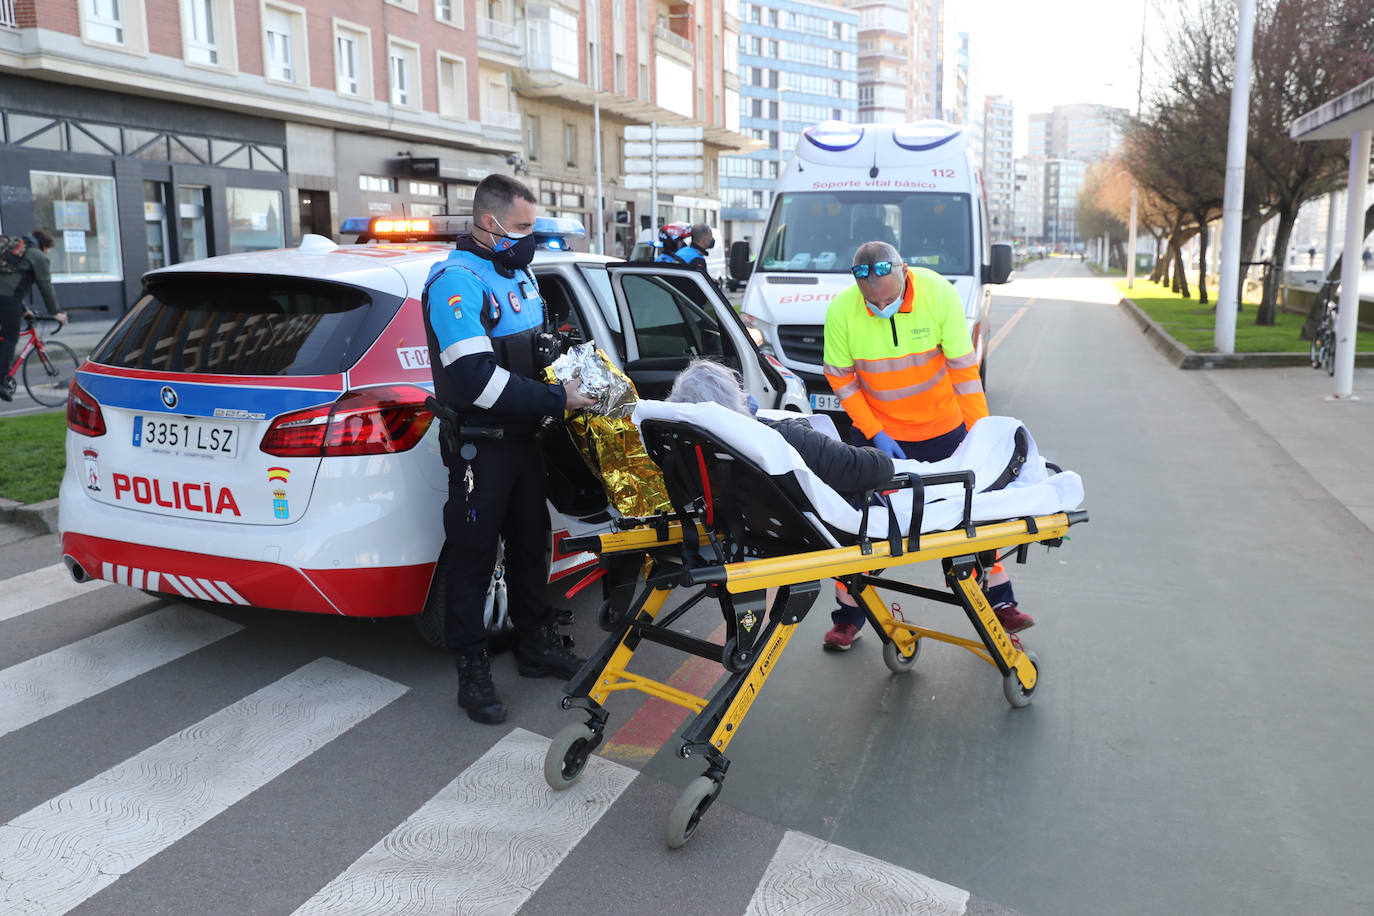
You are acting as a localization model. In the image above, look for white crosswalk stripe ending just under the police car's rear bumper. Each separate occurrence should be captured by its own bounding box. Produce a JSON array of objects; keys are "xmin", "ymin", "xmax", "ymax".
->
[{"xmin": 0, "ymin": 606, "xmax": 243, "ymax": 735}]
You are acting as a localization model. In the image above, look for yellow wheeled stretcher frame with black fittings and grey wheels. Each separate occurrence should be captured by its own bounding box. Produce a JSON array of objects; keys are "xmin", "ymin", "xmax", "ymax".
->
[{"xmin": 544, "ymin": 511, "xmax": 1087, "ymax": 847}]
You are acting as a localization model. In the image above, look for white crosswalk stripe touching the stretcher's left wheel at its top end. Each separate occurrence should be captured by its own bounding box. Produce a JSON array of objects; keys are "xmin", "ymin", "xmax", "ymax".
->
[{"xmin": 295, "ymin": 728, "xmax": 635, "ymax": 916}]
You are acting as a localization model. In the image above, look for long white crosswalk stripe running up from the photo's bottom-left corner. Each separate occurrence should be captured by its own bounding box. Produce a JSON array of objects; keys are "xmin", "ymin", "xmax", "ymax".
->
[{"xmin": 0, "ymin": 658, "xmax": 407, "ymax": 915}]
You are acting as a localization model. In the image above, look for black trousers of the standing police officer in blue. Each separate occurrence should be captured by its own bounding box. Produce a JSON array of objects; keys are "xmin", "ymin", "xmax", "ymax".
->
[{"xmin": 442, "ymin": 437, "xmax": 554, "ymax": 652}]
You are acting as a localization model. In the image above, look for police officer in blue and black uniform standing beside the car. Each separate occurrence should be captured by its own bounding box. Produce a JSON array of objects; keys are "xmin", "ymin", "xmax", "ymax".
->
[{"xmin": 422, "ymin": 174, "xmax": 594, "ymax": 722}]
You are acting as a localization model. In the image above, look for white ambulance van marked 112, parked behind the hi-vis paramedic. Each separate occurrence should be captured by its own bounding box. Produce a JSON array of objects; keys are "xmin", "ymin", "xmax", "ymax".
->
[{"xmin": 741, "ymin": 121, "xmax": 1011, "ymax": 413}]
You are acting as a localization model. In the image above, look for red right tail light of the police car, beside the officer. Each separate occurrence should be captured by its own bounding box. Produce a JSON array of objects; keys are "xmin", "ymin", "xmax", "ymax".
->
[{"xmin": 260, "ymin": 385, "xmax": 434, "ymax": 457}]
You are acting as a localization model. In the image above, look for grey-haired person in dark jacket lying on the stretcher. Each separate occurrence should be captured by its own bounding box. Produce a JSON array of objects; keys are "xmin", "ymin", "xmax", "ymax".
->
[{"xmin": 665, "ymin": 360, "xmax": 893, "ymax": 507}]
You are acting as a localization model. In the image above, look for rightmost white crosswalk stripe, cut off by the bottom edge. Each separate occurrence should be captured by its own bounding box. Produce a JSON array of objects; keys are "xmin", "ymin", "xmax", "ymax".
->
[{"xmin": 746, "ymin": 831, "xmax": 969, "ymax": 916}]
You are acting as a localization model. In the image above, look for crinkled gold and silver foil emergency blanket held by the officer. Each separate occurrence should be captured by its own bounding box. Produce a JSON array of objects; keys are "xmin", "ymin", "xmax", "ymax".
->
[{"xmin": 544, "ymin": 341, "xmax": 672, "ymax": 516}]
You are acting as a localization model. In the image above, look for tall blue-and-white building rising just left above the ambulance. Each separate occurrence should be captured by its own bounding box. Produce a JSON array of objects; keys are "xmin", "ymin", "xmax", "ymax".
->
[{"xmin": 720, "ymin": 0, "xmax": 859, "ymax": 242}]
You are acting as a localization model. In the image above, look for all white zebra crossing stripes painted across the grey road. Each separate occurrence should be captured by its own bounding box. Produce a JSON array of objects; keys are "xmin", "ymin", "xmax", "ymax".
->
[{"xmin": 0, "ymin": 570, "xmax": 989, "ymax": 916}]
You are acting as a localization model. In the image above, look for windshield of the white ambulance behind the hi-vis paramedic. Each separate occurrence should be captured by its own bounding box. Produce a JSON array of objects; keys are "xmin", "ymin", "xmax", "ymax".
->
[{"xmin": 754, "ymin": 191, "xmax": 973, "ymax": 276}]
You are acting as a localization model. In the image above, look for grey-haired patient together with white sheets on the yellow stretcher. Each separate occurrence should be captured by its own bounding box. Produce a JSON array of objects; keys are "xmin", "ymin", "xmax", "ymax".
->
[{"xmin": 635, "ymin": 361, "xmax": 1083, "ymax": 547}]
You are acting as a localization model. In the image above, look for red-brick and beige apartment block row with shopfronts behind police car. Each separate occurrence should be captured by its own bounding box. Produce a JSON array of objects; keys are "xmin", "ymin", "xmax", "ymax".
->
[{"xmin": 0, "ymin": 0, "xmax": 750, "ymax": 312}]
